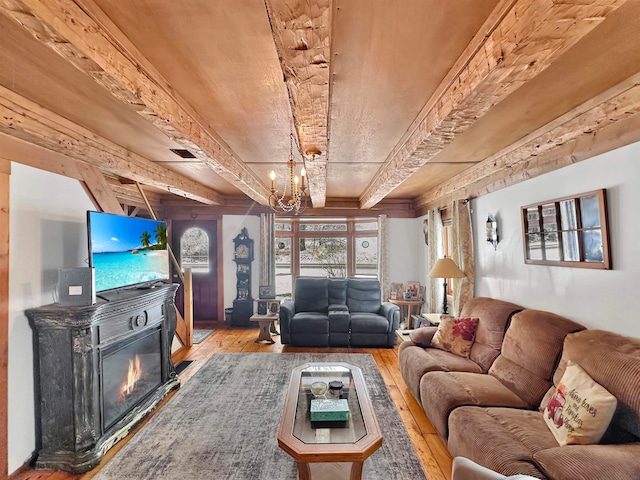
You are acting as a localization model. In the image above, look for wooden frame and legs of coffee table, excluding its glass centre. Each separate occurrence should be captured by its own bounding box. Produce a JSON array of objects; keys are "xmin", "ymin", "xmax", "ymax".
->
[{"xmin": 278, "ymin": 362, "xmax": 382, "ymax": 480}]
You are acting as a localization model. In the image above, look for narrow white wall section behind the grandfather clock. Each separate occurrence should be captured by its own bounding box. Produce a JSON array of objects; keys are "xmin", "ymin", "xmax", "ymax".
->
[{"xmin": 222, "ymin": 215, "xmax": 260, "ymax": 308}]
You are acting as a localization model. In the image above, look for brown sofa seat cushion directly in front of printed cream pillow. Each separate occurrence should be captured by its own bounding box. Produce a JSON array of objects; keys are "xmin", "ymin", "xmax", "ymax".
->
[{"xmin": 447, "ymin": 407, "xmax": 556, "ymax": 479}]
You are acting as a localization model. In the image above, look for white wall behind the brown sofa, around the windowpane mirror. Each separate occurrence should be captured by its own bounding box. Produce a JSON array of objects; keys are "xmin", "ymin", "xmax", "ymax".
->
[{"xmin": 472, "ymin": 143, "xmax": 640, "ymax": 337}]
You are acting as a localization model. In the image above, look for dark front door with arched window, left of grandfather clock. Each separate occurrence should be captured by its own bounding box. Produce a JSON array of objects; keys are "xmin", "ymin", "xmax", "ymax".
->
[{"xmin": 171, "ymin": 220, "xmax": 218, "ymax": 322}]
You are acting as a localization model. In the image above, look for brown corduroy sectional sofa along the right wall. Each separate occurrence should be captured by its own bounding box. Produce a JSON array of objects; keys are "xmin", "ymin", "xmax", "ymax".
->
[{"xmin": 399, "ymin": 299, "xmax": 640, "ymax": 480}]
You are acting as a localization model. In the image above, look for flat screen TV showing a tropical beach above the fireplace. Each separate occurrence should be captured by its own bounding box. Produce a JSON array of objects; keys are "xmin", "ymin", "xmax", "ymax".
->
[{"xmin": 87, "ymin": 211, "xmax": 169, "ymax": 292}]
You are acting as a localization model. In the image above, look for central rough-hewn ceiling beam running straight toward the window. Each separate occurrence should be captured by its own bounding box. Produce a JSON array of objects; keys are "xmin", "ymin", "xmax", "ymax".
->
[{"xmin": 265, "ymin": 0, "xmax": 333, "ymax": 208}]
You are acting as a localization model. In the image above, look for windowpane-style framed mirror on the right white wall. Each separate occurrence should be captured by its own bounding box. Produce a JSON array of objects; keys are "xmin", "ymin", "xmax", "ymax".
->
[{"xmin": 522, "ymin": 189, "xmax": 611, "ymax": 270}]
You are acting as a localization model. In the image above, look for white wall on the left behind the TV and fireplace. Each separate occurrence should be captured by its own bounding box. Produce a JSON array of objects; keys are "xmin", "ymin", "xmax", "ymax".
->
[{"xmin": 8, "ymin": 163, "xmax": 94, "ymax": 473}]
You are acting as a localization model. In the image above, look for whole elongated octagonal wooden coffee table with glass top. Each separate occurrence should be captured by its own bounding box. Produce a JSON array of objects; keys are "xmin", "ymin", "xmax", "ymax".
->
[{"xmin": 278, "ymin": 363, "xmax": 382, "ymax": 480}]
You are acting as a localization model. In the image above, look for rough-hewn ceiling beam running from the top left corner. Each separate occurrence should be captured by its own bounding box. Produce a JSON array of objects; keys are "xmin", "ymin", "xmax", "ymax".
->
[{"xmin": 0, "ymin": 0, "xmax": 269, "ymax": 204}]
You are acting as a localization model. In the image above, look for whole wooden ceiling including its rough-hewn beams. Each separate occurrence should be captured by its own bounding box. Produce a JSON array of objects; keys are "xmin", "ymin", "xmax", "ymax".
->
[{"xmin": 0, "ymin": 0, "xmax": 640, "ymax": 215}]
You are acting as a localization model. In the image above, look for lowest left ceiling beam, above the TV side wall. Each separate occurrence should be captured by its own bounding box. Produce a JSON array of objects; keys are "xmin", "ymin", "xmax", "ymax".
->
[{"xmin": 0, "ymin": 86, "xmax": 224, "ymax": 204}]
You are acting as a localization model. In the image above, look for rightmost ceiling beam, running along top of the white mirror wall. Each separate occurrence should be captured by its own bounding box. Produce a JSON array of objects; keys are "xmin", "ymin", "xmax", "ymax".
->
[{"xmin": 415, "ymin": 74, "xmax": 640, "ymax": 214}]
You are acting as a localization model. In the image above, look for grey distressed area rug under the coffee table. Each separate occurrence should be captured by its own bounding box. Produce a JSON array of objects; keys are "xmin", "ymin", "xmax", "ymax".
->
[{"xmin": 94, "ymin": 353, "xmax": 426, "ymax": 480}]
